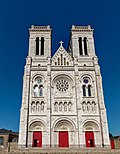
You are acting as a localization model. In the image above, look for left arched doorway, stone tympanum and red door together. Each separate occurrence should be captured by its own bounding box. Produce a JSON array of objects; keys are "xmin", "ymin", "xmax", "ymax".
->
[{"xmin": 30, "ymin": 121, "xmax": 45, "ymax": 147}]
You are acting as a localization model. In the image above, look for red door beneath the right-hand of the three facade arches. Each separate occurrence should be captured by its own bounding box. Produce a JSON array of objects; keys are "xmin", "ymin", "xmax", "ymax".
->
[{"xmin": 85, "ymin": 131, "xmax": 95, "ymax": 147}]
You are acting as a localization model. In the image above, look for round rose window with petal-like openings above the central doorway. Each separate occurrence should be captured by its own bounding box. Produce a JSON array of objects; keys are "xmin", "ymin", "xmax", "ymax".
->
[{"xmin": 56, "ymin": 80, "xmax": 69, "ymax": 92}]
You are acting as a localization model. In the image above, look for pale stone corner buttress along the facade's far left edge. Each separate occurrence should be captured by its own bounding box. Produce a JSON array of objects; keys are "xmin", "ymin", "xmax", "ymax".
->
[{"xmin": 18, "ymin": 57, "xmax": 31, "ymax": 147}]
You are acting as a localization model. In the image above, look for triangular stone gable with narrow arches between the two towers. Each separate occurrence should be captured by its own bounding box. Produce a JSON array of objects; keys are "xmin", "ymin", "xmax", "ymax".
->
[{"xmin": 52, "ymin": 44, "xmax": 73, "ymax": 66}]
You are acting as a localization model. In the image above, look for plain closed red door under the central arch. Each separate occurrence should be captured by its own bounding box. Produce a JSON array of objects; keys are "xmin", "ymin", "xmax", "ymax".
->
[{"xmin": 59, "ymin": 131, "xmax": 69, "ymax": 147}]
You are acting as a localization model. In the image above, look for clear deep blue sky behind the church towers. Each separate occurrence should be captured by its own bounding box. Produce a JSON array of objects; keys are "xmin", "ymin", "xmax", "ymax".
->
[{"xmin": 0, "ymin": 0, "xmax": 120, "ymax": 135}]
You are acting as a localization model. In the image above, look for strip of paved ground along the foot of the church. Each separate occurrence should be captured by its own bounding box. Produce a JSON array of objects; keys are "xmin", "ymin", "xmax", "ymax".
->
[{"xmin": 5, "ymin": 148, "xmax": 120, "ymax": 154}]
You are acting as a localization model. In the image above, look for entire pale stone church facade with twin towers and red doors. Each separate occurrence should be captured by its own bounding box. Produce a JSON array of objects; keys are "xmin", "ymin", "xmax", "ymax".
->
[{"xmin": 19, "ymin": 25, "xmax": 110, "ymax": 148}]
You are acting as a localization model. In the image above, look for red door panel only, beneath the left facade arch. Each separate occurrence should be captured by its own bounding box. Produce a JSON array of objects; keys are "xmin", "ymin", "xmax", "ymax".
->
[{"xmin": 33, "ymin": 132, "xmax": 42, "ymax": 147}]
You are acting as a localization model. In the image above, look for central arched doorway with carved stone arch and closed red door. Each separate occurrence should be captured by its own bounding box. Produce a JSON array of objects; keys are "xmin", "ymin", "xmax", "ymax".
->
[{"xmin": 54, "ymin": 120, "xmax": 74, "ymax": 147}]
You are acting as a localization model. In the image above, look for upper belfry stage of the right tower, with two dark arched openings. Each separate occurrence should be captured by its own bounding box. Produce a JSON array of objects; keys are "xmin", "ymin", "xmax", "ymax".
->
[{"xmin": 68, "ymin": 25, "xmax": 95, "ymax": 58}]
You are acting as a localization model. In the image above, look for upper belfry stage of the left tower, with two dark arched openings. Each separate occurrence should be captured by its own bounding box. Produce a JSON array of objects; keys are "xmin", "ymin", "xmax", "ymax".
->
[{"xmin": 29, "ymin": 25, "xmax": 51, "ymax": 60}]
